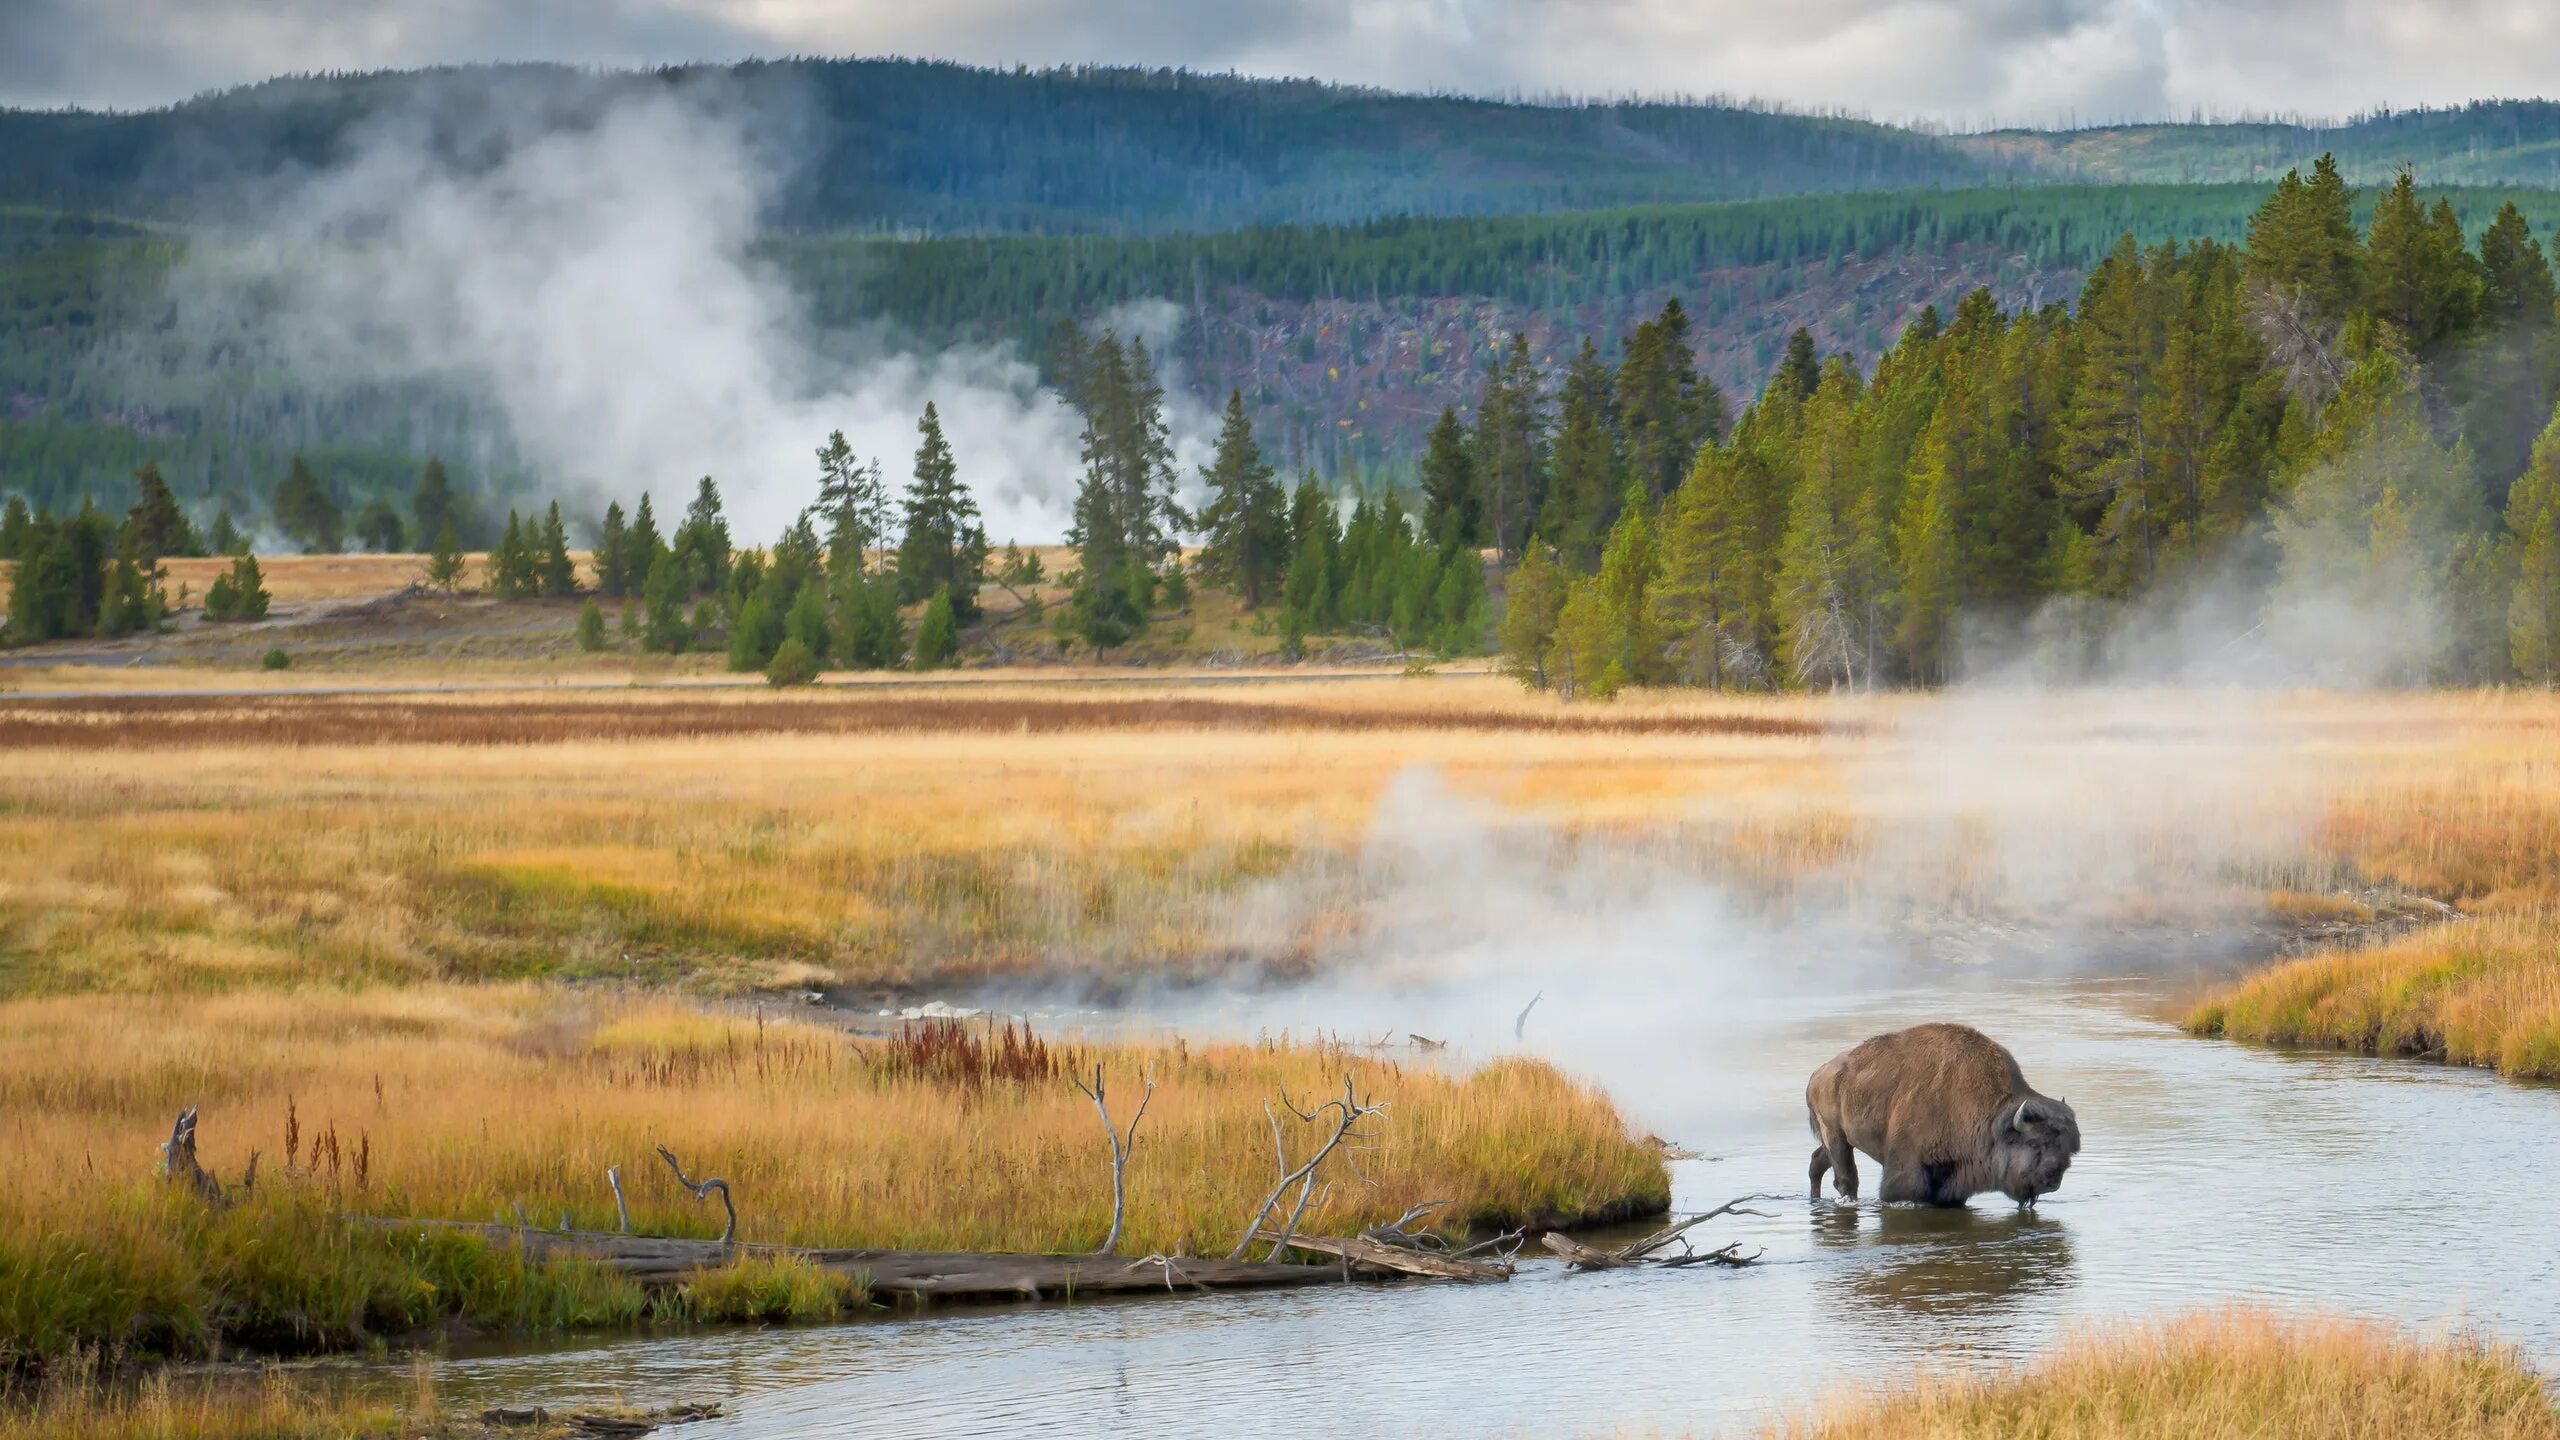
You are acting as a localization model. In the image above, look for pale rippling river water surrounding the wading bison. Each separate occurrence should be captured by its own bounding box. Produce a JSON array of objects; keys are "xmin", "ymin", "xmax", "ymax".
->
[{"xmin": 404, "ymin": 979, "xmax": 2560, "ymax": 1440}]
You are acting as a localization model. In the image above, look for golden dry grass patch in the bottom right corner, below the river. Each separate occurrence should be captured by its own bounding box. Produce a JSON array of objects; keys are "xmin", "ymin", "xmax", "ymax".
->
[{"xmin": 1764, "ymin": 1309, "xmax": 2560, "ymax": 1440}]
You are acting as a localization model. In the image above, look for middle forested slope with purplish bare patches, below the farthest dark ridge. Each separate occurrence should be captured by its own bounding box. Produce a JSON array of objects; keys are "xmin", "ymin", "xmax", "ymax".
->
[{"xmin": 15, "ymin": 187, "xmax": 2560, "ymax": 515}]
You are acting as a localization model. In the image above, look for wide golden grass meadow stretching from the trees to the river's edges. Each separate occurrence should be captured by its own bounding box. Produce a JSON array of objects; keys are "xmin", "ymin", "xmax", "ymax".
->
[{"xmin": 15, "ymin": 676, "xmax": 2560, "ymax": 1358}]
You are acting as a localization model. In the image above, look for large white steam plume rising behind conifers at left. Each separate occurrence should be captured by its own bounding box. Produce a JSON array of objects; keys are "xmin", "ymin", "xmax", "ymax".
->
[{"xmin": 172, "ymin": 92, "xmax": 1177, "ymax": 543}]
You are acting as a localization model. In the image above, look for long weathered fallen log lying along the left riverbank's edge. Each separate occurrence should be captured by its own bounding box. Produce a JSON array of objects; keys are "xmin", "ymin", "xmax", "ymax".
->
[{"xmin": 376, "ymin": 1220, "xmax": 1341, "ymax": 1299}]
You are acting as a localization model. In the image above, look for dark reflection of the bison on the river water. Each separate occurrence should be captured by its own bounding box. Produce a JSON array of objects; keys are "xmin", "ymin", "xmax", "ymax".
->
[{"xmin": 1812, "ymin": 1202, "xmax": 2076, "ymax": 1325}]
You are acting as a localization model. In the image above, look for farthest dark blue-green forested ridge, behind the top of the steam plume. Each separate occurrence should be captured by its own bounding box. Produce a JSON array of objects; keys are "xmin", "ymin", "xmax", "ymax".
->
[{"xmin": 0, "ymin": 59, "xmax": 2007, "ymax": 233}]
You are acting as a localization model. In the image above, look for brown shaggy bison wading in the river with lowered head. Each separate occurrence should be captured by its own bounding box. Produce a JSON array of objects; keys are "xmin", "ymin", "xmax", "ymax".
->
[{"xmin": 1805, "ymin": 1025, "xmax": 2079, "ymax": 1204}]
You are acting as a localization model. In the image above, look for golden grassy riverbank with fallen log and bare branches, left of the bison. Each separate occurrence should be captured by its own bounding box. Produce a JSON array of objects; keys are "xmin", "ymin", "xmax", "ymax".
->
[{"xmin": 0, "ymin": 986, "xmax": 1669, "ymax": 1363}]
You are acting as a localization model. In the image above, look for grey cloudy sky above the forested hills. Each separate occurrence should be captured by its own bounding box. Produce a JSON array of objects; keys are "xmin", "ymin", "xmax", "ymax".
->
[{"xmin": 0, "ymin": 0, "xmax": 2560, "ymax": 126}]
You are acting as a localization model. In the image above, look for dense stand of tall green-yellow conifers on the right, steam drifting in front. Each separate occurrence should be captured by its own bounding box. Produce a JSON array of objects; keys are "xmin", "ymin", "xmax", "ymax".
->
[{"xmin": 1474, "ymin": 159, "xmax": 2560, "ymax": 694}]
